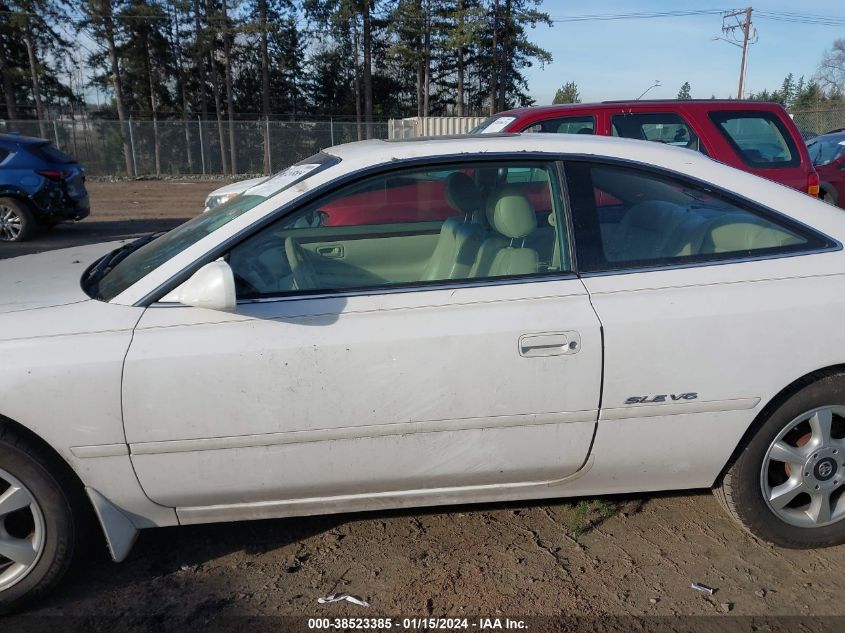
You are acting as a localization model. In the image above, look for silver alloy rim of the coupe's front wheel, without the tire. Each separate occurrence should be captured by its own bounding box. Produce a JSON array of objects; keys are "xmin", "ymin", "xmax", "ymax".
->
[{"xmin": 0, "ymin": 468, "xmax": 45, "ymax": 591}]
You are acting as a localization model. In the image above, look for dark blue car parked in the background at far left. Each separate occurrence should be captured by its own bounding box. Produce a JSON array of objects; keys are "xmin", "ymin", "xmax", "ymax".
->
[{"xmin": 0, "ymin": 134, "xmax": 91, "ymax": 242}]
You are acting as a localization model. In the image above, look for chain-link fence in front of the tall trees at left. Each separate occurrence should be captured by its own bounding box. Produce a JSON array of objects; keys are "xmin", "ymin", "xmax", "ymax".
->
[{"xmin": 0, "ymin": 118, "xmax": 387, "ymax": 177}]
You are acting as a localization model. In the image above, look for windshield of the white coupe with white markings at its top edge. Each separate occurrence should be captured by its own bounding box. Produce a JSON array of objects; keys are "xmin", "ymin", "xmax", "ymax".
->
[{"xmin": 82, "ymin": 153, "xmax": 340, "ymax": 301}]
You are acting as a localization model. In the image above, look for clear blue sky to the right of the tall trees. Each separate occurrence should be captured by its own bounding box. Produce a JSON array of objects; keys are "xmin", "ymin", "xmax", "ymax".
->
[{"xmin": 526, "ymin": 0, "xmax": 845, "ymax": 105}]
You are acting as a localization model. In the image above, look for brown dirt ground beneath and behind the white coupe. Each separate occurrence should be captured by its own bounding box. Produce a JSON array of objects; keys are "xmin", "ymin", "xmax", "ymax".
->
[{"xmin": 0, "ymin": 181, "xmax": 845, "ymax": 631}]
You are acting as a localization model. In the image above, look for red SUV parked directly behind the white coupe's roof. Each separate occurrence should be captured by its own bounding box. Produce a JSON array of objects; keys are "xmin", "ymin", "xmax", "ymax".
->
[{"xmin": 473, "ymin": 99, "xmax": 819, "ymax": 196}]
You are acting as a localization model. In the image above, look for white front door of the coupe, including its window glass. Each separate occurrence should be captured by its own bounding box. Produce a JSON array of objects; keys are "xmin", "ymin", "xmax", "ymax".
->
[{"xmin": 123, "ymin": 160, "xmax": 602, "ymax": 520}]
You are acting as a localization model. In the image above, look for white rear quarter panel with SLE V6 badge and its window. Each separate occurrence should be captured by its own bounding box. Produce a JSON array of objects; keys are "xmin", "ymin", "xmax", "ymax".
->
[{"xmin": 566, "ymin": 161, "xmax": 841, "ymax": 492}]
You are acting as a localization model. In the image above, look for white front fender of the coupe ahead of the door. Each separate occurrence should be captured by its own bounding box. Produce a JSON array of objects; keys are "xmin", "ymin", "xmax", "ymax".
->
[{"xmin": 0, "ymin": 300, "xmax": 177, "ymax": 532}]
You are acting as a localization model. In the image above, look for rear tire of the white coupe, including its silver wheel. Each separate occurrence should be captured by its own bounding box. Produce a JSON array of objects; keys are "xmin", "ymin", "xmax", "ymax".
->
[{"xmin": 714, "ymin": 373, "xmax": 845, "ymax": 549}]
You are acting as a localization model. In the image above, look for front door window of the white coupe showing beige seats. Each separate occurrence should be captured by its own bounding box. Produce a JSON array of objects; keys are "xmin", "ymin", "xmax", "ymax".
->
[{"xmin": 228, "ymin": 161, "xmax": 569, "ymax": 299}]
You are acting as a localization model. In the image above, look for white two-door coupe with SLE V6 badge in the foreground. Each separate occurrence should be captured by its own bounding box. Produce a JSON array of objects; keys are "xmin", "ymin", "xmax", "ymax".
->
[{"xmin": 0, "ymin": 134, "xmax": 845, "ymax": 609}]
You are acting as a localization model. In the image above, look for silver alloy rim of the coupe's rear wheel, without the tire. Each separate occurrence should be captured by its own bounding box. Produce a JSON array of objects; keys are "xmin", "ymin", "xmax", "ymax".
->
[{"xmin": 760, "ymin": 406, "xmax": 845, "ymax": 528}]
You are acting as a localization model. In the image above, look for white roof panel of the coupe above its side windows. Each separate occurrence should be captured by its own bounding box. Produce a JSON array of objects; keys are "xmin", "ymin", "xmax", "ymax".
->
[{"xmin": 324, "ymin": 134, "xmax": 714, "ymax": 171}]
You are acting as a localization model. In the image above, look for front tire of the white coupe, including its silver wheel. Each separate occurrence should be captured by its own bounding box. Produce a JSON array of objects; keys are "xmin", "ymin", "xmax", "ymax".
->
[{"xmin": 0, "ymin": 425, "xmax": 78, "ymax": 614}]
